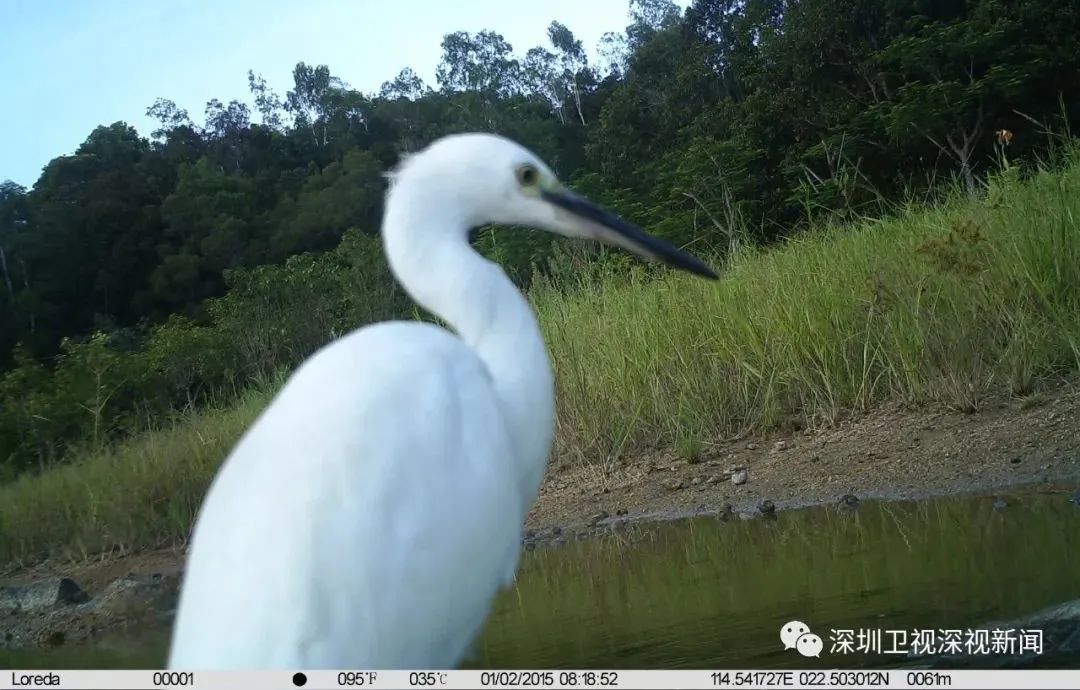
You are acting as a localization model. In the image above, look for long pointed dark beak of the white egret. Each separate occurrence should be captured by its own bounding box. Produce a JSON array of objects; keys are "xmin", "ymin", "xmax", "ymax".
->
[{"xmin": 540, "ymin": 188, "xmax": 717, "ymax": 280}]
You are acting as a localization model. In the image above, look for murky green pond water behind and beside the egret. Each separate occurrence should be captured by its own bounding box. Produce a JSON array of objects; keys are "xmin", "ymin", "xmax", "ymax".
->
[{"xmin": 0, "ymin": 492, "xmax": 1080, "ymax": 668}]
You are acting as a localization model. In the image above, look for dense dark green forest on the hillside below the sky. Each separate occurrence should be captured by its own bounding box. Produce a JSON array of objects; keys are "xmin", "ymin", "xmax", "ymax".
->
[{"xmin": 0, "ymin": 0, "xmax": 1080, "ymax": 476}]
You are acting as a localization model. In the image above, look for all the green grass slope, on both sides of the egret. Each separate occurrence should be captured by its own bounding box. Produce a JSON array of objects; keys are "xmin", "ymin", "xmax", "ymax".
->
[{"xmin": 0, "ymin": 155, "xmax": 1080, "ymax": 564}]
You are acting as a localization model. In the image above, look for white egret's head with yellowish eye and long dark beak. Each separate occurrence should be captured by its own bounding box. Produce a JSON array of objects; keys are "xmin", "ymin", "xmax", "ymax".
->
[{"xmin": 393, "ymin": 134, "xmax": 716, "ymax": 279}]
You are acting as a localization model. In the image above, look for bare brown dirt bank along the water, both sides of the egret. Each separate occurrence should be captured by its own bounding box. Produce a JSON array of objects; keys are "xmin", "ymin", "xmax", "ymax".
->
[{"xmin": 0, "ymin": 387, "xmax": 1080, "ymax": 647}]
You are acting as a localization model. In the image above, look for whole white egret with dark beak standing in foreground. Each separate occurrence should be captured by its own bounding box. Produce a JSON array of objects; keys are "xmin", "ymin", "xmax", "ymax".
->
[{"xmin": 168, "ymin": 134, "xmax": 715, "ymax": 669}]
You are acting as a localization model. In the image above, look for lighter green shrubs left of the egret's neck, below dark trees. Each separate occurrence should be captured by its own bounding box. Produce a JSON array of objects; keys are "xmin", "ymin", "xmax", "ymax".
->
[{"xmin": 0, "ymin": 232, "xmax": 411, "ymax": 475}]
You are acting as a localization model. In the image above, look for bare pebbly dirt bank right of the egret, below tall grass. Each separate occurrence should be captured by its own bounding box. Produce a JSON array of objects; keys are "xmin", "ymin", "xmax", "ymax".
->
[{"xmin": 528, "ymin": 387, "xmax": 1080, "ymax": 528}]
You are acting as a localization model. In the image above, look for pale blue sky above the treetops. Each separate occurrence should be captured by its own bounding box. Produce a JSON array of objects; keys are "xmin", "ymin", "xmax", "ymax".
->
[{"xmin": 0, "ymin": 0, "xmax": 688, "ymax": 187}]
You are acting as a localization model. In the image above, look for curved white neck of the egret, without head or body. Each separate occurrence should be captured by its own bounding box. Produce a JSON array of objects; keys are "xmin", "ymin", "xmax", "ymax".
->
[{"xmin": 382, "ymin": 178, "xmax": 554, "ymax": 517}]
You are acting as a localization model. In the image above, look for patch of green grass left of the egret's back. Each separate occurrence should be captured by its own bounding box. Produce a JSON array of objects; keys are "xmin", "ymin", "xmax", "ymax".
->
[{"xmin": 0, "ymin": 387, "xmax": 271, "ymax": 566}]
